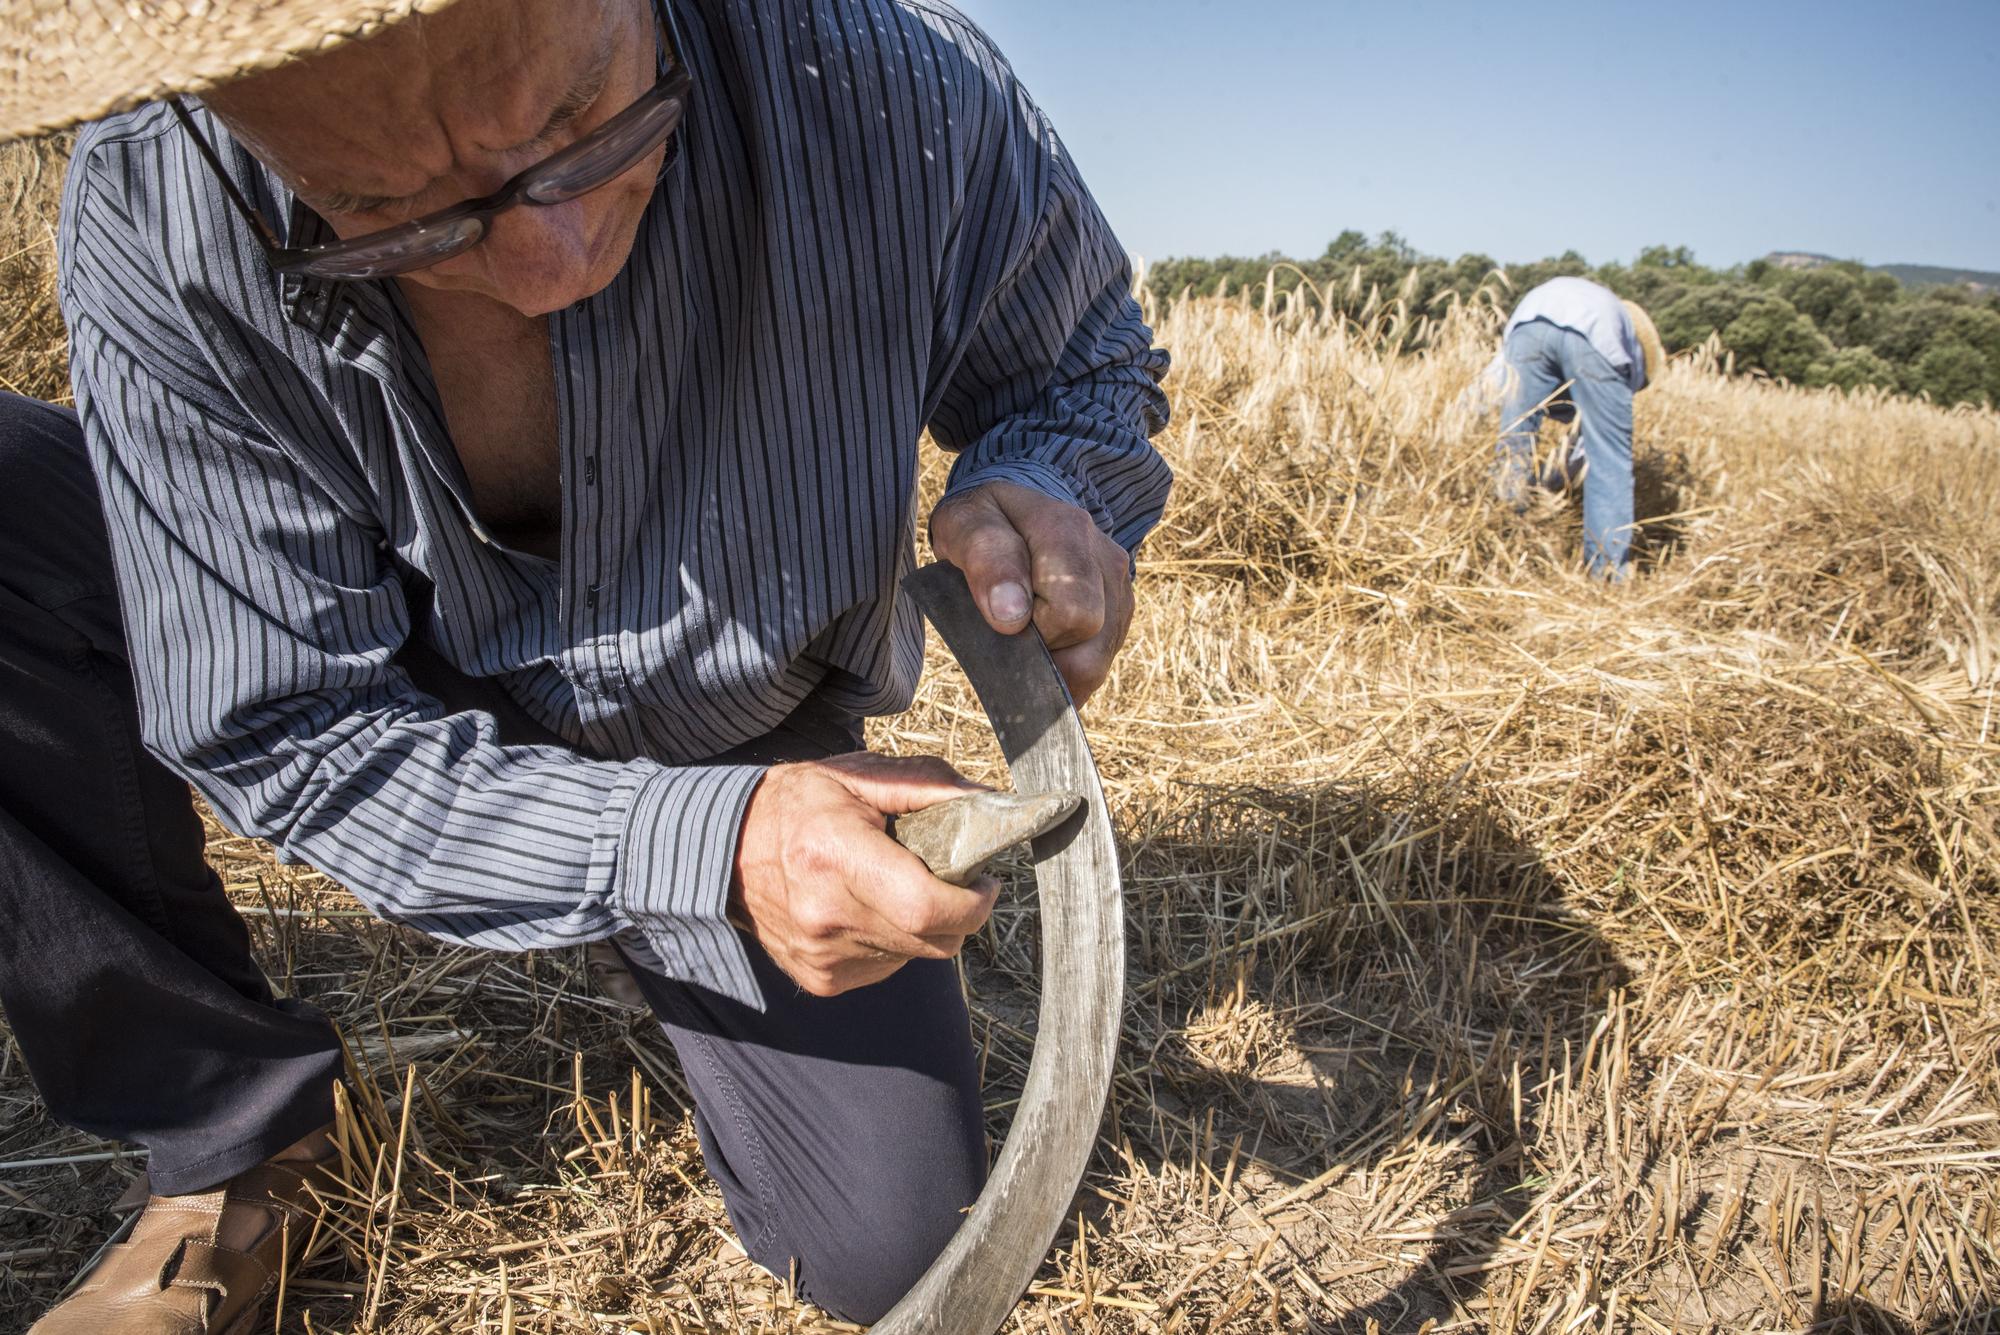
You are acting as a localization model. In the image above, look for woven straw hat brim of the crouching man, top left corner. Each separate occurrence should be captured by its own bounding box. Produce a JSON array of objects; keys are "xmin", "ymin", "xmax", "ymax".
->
[{"xmin": 0, "ymin": 0, "xmax": 464, "ymax": 140}]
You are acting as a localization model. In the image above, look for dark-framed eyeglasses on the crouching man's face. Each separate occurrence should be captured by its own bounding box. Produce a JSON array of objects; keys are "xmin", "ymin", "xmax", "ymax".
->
[{"xmin": 172, "ymin": 12, "xmax": 694, "ymax": 280}]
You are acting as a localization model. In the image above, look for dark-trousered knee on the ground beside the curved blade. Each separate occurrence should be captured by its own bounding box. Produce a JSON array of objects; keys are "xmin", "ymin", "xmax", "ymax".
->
[{"xmin": 660, "ymin": 951, "xmax": 986, "ymax": 1321}]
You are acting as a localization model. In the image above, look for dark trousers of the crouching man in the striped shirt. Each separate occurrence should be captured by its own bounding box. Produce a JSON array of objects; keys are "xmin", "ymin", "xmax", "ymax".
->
[{"xmin": 0, "ymin": 394, "xmax": 984, "ymax": 1321}]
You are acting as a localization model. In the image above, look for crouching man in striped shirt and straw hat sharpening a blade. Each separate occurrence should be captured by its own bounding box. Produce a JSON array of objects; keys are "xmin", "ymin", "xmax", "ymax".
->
[{"xmin": 0, "ymin": 0, "xmax": 1168, "ymax": 1333}]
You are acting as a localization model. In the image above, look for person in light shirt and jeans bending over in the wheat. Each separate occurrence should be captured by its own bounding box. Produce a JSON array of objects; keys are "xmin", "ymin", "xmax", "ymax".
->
[{"xmin": 1490, "ymin": 278, "xmax": 1666, "ymax": 580}]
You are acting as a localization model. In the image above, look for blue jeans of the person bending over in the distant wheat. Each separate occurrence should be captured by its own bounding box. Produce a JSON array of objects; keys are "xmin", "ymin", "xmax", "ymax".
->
[{"xmin": 1500, "ymin": 320, "xmax": 1632, "ymax": 580}]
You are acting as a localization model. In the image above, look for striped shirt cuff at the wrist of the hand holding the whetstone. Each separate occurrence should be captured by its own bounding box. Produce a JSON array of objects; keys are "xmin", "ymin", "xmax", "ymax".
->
[{"xmin": 594, "ymin": 765, "xmax": 764, "ymax": 1011}]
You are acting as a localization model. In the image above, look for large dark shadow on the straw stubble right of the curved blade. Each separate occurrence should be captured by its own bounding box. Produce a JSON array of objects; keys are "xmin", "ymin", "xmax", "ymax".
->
[{"xmin": 972, "ymin": 781, "xmax": 1626, "ymax": 1333}]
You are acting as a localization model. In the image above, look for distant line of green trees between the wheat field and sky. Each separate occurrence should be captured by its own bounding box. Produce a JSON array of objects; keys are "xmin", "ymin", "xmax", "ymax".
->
[{"xmin": 1146, "ymin": 232, "xmax": 2000, "ymax": 406}]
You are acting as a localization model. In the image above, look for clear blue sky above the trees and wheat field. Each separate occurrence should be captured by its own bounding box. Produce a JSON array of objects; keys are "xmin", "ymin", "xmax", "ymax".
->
[{"xmin": 958, "ymin": 0, "xmax": 2000, "ymax": 270}]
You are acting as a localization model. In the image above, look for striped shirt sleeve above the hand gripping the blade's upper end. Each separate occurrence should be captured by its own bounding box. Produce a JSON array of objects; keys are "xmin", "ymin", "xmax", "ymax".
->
[{"xmin": 930, "ymin": 108, "xmax": 1172, "ymax": 552}]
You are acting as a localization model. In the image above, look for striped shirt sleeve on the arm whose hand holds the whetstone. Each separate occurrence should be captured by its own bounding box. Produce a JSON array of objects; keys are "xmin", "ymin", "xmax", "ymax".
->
[{"xmin": 68, "ymin": 305, "xmax": 762, "ymax": 1005}]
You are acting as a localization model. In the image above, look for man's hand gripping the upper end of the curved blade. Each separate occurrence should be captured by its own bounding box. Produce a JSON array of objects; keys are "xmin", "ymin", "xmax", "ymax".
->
[{"xmin": 930, "ymin": 482, "xmax": 1132, "ymax": 705}]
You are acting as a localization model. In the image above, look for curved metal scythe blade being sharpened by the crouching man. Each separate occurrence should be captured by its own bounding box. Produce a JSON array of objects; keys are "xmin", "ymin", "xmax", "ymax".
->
[{"xmin": 874, "ymin": 564, "xmax": 1124, "ymax": 1335}]
